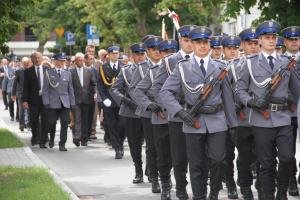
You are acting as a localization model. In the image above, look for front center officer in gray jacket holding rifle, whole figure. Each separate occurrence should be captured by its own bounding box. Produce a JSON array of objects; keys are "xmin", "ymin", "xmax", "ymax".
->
[{"xmin": 160, "ymin": 26, "xmax": 237, "ymax": 200}]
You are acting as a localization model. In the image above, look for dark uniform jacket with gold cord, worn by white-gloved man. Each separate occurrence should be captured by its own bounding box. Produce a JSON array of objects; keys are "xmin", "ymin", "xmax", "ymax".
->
[{"xmin": 98, "ymin": 62, "xmax": 122, "ymax": 107}]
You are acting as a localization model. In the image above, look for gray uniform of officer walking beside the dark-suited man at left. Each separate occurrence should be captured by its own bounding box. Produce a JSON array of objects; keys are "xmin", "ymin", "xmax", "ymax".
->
[{"xmin": 42, "ymin": 68, "xmax": 75, "ymax": 147}]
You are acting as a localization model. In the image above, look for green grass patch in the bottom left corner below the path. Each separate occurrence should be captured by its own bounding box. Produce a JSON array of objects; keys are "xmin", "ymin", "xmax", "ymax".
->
[{"xmin": 0, "ymin": 167, "xmax": 71, "ymax": 200}]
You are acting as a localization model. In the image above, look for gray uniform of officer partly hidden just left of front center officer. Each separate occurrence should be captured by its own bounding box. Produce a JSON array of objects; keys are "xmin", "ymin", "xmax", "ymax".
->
[{"xmin": 150, "ymin": 51, "xmax": 188, "ymax": 191}]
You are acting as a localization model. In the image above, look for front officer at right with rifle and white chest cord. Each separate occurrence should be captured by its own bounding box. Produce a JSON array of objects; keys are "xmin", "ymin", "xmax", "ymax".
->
[{"xmin": 237, "ymin": 21, "xmax": 300, "ymax": 200}]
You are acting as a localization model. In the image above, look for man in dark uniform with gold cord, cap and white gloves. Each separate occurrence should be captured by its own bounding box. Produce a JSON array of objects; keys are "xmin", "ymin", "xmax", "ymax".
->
[{"xmin": 98, "ymin": 46, "xmax": 125, "ymax": 159}]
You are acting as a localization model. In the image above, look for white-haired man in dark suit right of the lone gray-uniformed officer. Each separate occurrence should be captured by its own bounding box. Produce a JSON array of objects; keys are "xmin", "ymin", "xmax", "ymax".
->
[{"xmin": 70, "ymin": 53, "xmax": 97, "ymax": 146}]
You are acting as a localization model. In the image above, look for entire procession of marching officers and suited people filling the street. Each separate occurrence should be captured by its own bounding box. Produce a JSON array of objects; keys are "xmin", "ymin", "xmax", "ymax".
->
[{"xmin": 0, "ymin": 20, "xmax": 300, "ymax": 200}]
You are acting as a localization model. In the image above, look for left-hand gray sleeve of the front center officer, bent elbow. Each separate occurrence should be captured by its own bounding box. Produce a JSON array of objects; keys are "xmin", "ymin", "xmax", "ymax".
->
[{"xmin": 159, "ymin": 65, "xmax": 182, "ymax": 118}]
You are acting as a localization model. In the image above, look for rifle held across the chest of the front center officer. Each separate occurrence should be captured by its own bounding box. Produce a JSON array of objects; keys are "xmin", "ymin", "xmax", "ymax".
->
[{"xmin": 189, "ymin": 67, "xmax": 228, "ymax": 129}]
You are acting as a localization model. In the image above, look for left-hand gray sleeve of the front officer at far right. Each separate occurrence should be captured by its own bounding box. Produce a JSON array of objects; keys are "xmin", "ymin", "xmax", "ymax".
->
[{"xmin": 236, "ymin": 59, "xmax": 251, "ymax": 106}]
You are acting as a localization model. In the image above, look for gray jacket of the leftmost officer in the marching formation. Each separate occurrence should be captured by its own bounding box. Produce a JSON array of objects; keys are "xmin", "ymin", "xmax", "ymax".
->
[{"xmin": 110, "ymin": 64, "xmax": 139, "ymax": 118}]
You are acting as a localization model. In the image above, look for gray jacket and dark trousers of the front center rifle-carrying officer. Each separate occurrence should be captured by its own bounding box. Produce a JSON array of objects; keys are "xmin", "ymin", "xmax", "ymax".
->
[{"xmin": 160, "ymin": 54, "xmax": 237, "ymax": 198}]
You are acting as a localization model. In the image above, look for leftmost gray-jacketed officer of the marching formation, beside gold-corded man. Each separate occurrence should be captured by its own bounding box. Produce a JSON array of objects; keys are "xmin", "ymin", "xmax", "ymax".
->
[{"xmin": 110, "ymin": 43, "xmax": 146, "ymax": 183}]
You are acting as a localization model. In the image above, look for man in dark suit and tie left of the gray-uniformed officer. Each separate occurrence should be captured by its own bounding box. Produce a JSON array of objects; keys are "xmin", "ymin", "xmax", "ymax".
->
[{"xmin": 23, "ymin": 52, "xmax": 48, "ymax": 148}]
